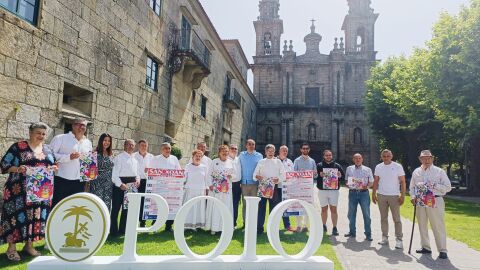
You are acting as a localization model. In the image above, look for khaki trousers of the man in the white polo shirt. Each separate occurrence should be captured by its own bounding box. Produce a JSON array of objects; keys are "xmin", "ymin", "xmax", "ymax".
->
[{"xmin": 377, "ymin": 194, "xmax": 403, "ymax": 240}]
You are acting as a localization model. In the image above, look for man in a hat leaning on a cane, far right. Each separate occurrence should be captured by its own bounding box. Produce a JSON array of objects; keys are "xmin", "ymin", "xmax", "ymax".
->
[{"xmin": 410, "ymin": 150, "xmax": 452, "ymax": 259}]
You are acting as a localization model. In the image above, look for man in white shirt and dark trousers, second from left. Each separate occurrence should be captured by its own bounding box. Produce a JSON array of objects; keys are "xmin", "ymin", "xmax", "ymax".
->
[{"xmin": 50, "ymin": 119, "xmax": 92, "ymax": 208}]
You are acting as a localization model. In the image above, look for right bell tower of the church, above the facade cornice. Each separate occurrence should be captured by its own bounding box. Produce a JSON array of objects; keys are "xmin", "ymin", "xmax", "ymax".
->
[{"xmin": 342, "ymin": 0, "xmax": 378, "ymax": 55}]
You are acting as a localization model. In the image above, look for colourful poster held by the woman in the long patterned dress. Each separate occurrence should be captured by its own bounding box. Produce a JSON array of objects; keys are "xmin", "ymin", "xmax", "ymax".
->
[{"xmin": 26, "ymin": 167, "xmax": 53, "ymax": 203}]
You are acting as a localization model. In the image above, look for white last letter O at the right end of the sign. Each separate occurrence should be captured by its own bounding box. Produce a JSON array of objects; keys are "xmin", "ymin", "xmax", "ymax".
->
[{"xmin": 267, "ymin": 199, "xmax": 323, "ymax": 260}]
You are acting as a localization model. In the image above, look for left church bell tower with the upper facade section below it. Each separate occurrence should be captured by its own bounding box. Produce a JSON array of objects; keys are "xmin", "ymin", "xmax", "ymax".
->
[{"xmin": 252, "ymin": 0, "xmax": 283, "ymax": 104}]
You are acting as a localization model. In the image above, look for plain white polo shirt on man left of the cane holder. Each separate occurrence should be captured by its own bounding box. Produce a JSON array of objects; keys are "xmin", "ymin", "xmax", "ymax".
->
[{"xmin": 375, "ymin": 161, "xmax": 405, "ymax": 196}]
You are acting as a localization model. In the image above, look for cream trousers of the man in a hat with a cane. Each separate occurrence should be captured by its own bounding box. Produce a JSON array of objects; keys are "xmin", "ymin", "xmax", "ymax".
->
[{"xmin": 417, "ymin": 197, "xmax": 447, "ymax": 252}]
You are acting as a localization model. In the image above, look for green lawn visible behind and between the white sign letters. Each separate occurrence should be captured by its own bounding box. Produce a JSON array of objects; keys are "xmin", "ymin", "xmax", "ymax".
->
[{"xmin": 0, "ymin": 206, "xmax": 343, "ymax": 270}]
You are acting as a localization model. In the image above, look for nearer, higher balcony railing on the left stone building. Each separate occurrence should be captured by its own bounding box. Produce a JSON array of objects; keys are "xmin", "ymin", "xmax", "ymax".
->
[{"xmin": 178, "ymin": 29, "xmax": 211, "ymax": 70}]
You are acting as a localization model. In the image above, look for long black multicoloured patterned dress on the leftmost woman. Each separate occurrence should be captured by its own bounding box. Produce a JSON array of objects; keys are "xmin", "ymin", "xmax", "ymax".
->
[{"xmin": 0, "ymin": 141, "xmax": 55, "ymax": 243}]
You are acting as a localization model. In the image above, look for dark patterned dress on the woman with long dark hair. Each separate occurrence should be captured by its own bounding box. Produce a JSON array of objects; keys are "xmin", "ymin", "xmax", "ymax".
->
[{"xmin": 90, "ymin": 153, "xmax": 113, "ymax": 211}]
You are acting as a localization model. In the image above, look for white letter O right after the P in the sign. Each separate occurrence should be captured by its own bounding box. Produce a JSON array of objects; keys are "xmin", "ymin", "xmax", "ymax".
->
[{"xmin": 173, "ymin": 196, "xmax": 233, "ymax": 260}]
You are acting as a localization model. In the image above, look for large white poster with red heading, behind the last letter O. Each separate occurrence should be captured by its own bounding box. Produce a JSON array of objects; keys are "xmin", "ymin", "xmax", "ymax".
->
[{"xmin": 282, "ymin": 171, "xmax": 315, "ymax": 217}]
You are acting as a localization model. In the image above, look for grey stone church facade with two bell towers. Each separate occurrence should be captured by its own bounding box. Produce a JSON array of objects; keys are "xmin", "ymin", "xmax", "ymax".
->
[{"xmin": 252, "ymin": 0, "xmax": 378, "ymax": 165}]
